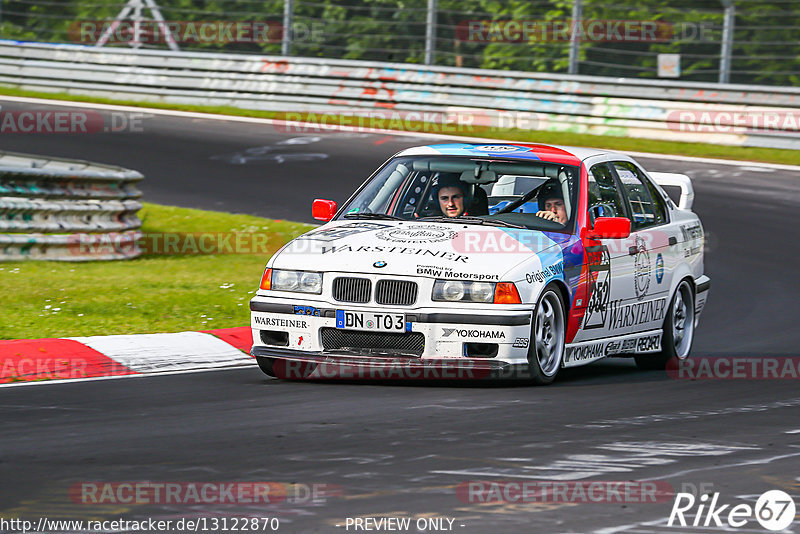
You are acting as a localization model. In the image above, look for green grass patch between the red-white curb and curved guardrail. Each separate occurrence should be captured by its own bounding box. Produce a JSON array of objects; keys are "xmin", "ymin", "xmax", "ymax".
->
[{"xmin": 0, "ymin": 204, "xmax": 312, "ymax": 339}]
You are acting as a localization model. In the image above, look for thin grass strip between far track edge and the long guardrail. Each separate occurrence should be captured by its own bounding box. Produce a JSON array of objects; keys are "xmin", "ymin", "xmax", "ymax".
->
[{"xmin": 0, "ymin": 86, "xmax": 800, "ymax": 165}]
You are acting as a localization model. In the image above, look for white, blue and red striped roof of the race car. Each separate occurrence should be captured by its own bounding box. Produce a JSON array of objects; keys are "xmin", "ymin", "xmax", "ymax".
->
[{"xmin": 397, "ymin": 142, "xmax": 621, "ymax": 165}]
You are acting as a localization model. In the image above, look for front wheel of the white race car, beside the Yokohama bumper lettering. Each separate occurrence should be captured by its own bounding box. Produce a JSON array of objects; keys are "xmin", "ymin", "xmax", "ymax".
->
[{"xmin": 528, "ymin": 285, "xmax": 567, "ymax": 386}]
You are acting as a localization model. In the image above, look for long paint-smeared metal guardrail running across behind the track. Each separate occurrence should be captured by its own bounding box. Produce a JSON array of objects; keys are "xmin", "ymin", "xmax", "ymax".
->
[{"xmin": 0, "ymin": 41, "xmax": 800, "ymax": 148}]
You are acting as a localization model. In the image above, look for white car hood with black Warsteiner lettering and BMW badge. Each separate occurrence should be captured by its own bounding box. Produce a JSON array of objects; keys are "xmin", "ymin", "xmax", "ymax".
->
[{"xmin": 270, "ymin": 221, "xmax": 568, "ymax": 280}]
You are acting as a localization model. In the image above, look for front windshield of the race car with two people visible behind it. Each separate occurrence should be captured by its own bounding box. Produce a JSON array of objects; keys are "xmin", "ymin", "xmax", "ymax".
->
[{"xmin": 338, "ymin": 156, "xmax": 579, "ymax": 232}]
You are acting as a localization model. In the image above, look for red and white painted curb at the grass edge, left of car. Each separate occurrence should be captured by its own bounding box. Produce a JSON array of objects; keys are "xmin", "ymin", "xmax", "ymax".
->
[{"xmin": 0, "ymin": 327, "xmax": 255, "ymax": 384}]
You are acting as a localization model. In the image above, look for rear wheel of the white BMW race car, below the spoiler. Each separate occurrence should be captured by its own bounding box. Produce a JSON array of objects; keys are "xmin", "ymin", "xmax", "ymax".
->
[{"xmin": 634, "ymin": 279, "xmax": 695, "ymax": 371}]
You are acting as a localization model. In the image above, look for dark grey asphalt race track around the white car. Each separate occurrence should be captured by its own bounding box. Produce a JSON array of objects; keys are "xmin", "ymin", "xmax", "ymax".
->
[{"xmin": 0, "ymin": 102, "xmax": 800, "ymax": 533}]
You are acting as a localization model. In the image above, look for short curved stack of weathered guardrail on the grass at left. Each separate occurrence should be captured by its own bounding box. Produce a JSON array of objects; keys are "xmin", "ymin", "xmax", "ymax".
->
[{"xmin": 0, "ymin": 152, "xmax": 143, "ymax": 261}]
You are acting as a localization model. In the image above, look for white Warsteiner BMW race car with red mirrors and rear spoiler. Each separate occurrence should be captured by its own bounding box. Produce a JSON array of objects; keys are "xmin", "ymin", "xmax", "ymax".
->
[{"xmin": 250, "ymin": 143, "xmax": 710, "ymax": 384}]
